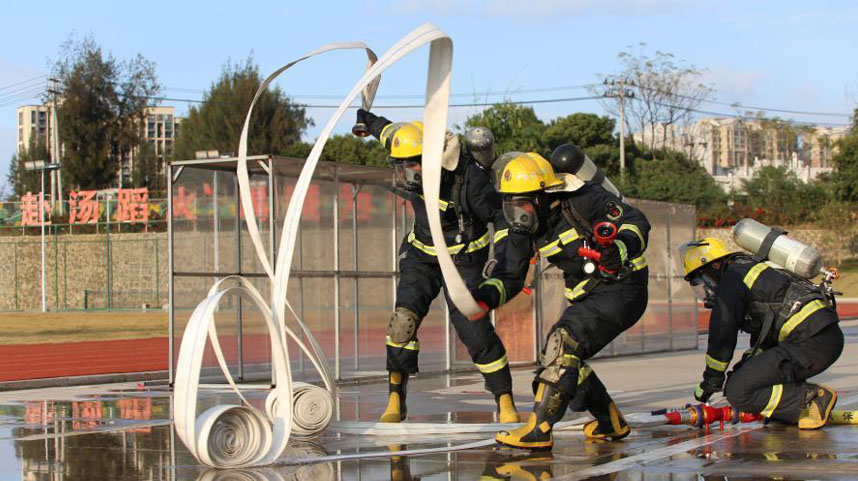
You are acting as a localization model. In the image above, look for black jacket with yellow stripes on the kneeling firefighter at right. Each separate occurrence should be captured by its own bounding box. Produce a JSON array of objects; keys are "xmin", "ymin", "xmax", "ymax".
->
[{"xmin": 703, "ymin": 255, "xmax": 838, "ymax": 390}]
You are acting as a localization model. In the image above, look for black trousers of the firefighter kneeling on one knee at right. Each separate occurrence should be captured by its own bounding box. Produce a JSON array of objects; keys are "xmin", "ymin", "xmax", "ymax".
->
[{"xmin": 724, "ymin": 324, "xmax": 843, "ymax": 423}]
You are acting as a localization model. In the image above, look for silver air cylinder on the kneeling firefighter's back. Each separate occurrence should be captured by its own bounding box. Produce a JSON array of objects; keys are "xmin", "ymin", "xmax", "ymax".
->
[{"xmin": 733, "ymin": 219, "xmax": 824, "ymax": 279}]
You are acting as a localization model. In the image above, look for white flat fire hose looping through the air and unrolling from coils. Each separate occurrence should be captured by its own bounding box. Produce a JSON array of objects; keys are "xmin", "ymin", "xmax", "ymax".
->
[{"xmin": 173, "ymin": 23, "xmax": 491, "ymax": 468}]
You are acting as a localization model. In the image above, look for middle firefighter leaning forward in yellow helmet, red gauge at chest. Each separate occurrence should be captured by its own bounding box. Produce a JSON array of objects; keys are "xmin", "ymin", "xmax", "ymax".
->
[{"xmin": 472, "ymin": 144, "xmax": 650, "ymax": 450}]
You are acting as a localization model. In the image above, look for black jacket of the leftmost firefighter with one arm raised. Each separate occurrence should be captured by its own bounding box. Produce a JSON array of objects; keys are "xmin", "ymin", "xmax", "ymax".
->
[{"xmin": 369, "ymin": 117, "xmax": 504, "ymax": 264}]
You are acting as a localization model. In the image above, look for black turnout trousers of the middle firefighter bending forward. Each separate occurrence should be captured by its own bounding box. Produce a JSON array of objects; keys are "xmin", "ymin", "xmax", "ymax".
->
[{"xmin": 544, "ymin": 269, "xmax": 649, "ymax": 418}]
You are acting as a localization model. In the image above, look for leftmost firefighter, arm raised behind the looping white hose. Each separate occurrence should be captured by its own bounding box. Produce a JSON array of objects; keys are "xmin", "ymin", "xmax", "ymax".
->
[{"xmin": 358, "ymin": 109, "xmax": 519, "ymax": 423}]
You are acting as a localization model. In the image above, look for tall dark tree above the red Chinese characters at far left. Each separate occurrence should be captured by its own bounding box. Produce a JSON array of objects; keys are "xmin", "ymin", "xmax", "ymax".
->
[{"xmin": 52, "ymin": 35, "xmax": 160, "ymax": 189}]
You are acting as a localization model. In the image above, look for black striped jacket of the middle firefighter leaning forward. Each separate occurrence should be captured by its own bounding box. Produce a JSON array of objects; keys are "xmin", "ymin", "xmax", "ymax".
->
[{"xmin": 480, "ymin": 182, "xmax": 650, "ymax": 309}]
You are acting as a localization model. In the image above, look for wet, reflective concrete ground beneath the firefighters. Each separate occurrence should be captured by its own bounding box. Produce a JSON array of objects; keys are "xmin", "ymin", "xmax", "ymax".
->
[{"xmin": 0, "ymin": 323, "xmax": 858, "ymax": 481}]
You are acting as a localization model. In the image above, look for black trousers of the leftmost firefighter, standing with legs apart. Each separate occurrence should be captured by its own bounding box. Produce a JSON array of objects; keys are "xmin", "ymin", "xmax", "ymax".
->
[{"xmin": 387, "ymin": 251, "xmax": 512, "ymax": 395}]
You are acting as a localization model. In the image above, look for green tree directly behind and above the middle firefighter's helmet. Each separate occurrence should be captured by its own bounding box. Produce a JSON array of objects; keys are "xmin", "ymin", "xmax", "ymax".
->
[{"xmin": 465, "ymin": 102, "xmax": 550, "ymax": 155}]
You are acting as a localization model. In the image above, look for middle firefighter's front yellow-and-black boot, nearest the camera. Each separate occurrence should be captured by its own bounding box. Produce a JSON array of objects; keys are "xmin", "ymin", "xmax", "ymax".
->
[{"xmin": 495, "ymin": 382, "xmax": 570, "ymax": 451}]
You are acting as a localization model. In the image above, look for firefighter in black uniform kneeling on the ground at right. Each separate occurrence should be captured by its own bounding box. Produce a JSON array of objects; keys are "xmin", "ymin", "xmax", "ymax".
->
[{"xmin": 680, "ymin": 237, "xmax": 843, "ymax": 429}]
